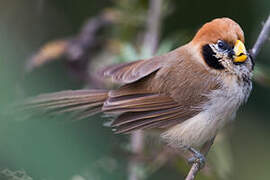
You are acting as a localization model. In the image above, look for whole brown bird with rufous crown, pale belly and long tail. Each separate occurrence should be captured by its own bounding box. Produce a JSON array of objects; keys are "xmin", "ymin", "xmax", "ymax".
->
[{"xmin": 25, "ymin": 17, "xmax": 254, "ymax": 167}]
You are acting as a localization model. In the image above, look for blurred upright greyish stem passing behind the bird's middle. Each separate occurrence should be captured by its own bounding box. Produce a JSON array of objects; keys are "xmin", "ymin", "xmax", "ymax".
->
[{"xmin": 129, "ymin": 0, "xmax": 162, "ymax": 180}]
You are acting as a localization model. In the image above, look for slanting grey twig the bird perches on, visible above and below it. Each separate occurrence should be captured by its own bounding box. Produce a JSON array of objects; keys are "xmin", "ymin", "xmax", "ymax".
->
[{"xmin": 186, "ymin": 16, "xmax": 270, "ymax": 180}]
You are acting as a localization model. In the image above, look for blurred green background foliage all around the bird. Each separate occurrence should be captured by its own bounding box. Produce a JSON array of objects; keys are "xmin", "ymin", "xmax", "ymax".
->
[{"xmin": 0, "ymin": 0, "xmax": 270, "ymax": 180}]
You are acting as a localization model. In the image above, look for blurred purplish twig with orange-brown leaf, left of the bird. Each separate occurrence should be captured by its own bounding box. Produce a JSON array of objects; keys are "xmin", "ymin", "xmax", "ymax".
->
[{"xmin": 26, "ymin": 13, "xmax": 114, "ymax": 88}]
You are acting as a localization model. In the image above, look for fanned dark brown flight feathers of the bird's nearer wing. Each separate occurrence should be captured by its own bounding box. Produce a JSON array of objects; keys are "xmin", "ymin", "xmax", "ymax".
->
[{"xmin": 102, "ymin": 88, "xmax": 200, "ymax": 133}]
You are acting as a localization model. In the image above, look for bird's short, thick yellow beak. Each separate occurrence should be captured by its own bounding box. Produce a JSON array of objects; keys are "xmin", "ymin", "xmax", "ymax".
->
[{"xmin": 233, "ymin": 40, "xmax": 248, "ymax": 63}]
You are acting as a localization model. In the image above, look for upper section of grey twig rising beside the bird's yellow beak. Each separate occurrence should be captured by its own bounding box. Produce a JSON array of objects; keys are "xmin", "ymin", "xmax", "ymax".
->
[{"xmin": 249, "ymin": 15, "xmax": 270, "ymax": 60}]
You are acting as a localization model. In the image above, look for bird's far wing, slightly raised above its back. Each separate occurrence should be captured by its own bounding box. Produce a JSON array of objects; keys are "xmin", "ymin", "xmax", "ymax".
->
[{"xmin": 101, "ymin": 56, "xmax": 163, "ymax": 84}]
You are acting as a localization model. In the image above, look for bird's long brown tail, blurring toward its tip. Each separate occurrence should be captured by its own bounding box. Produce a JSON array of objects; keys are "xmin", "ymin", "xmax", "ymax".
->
[{"xmin": 22, "ymin": 90, "xmax": 108, "ymax": 119}]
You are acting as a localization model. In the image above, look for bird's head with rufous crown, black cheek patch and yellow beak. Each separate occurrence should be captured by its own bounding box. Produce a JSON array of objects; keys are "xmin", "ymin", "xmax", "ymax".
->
[{"xmin": 191, "ymin": 18, "xmax": 254, "ymax": 73}]
